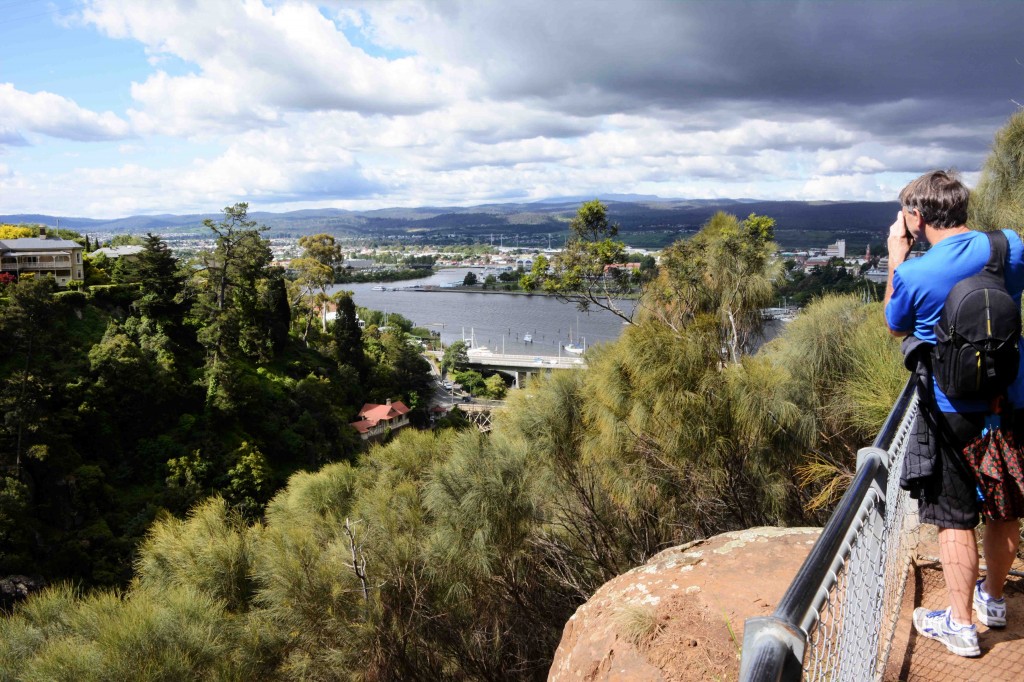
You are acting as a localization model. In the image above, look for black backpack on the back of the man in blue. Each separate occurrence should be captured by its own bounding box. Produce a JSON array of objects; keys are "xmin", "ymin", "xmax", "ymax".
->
[{"xmin": 932, "ymin": 231, "xmax": 1021, "ymax": 400}]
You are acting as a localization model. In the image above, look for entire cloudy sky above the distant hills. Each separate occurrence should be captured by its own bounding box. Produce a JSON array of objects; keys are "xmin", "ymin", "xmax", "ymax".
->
[{"xmin": 0, "ymin": 0, "xmax": 1024, "ymax": 217}]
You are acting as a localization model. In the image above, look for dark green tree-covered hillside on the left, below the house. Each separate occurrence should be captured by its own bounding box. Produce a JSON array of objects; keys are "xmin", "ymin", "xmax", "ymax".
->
[{"xmin": 0, "ymin": 205, "xmax": 430, "ymax": 586}]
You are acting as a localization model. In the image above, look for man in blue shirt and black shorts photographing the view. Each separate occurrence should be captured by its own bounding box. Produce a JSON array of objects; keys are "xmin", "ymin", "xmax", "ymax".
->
[{"xmin": 885, "ymin": 166, "xmax": 1024, "ymax": 656}]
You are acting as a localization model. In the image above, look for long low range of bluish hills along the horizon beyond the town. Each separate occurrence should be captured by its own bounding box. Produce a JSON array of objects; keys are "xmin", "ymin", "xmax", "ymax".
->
[{"xmin": 0, "ymin": 195, "xmax": 896, "ymax": 250}]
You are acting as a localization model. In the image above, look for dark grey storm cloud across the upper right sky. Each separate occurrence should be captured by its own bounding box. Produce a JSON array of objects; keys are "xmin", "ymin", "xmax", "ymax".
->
[{"xmin": 432, "ymin": 0, "xmax": 1024, "ymax": 155}]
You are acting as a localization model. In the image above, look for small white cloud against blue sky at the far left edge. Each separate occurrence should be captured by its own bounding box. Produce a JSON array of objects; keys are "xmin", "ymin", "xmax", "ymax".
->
[{"xmin": 0, "ymin": 83, "xmax": 130, "ymax": 143}]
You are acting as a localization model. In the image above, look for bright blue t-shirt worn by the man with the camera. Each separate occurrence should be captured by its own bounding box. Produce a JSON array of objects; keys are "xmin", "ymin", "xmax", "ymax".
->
[{"xmin": 886, "ymin": 229, "xmax": 1024, "ymax": 413}]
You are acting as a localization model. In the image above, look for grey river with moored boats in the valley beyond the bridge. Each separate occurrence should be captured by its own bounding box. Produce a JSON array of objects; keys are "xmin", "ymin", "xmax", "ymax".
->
[{"xmin": 331, "ymin": 268, "xmax": 633, "ymax": 356}]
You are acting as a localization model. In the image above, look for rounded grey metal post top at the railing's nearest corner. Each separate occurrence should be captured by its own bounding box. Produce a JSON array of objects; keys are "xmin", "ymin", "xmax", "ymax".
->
[{"xmin": 739, "ymin": 615, "xmax": 807, "ymax": 682}]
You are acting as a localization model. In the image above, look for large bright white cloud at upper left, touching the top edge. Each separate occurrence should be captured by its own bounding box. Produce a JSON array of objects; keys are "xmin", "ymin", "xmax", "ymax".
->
[{"xmin": 82, "ymin": 0, "xmax": 476, "ymax": 135}]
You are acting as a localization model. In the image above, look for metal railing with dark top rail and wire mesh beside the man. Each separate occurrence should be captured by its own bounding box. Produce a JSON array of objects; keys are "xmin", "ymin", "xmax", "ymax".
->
[{"xmin": 739, "ymin": 382, "xmax": 920, "ymax": 682}]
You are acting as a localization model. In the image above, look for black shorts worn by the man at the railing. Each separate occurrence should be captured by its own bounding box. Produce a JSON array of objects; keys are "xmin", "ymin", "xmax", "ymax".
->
[{"xmin": 918, "ymin": 410, "xmax": 1024, "ymax": 530}]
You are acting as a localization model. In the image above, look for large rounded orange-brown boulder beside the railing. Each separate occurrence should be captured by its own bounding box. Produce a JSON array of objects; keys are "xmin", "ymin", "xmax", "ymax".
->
[{"xmin": 548, "ymin": 527, "xmax": 820, "ymax": 682}]
